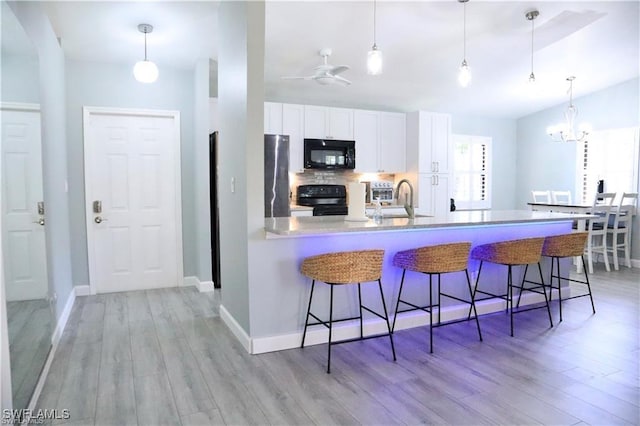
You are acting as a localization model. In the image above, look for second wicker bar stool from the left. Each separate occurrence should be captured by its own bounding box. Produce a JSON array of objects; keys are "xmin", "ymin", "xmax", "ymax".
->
[{"xmin": 391, "ymin": 242, "xmax": 482, "ymax": 353}]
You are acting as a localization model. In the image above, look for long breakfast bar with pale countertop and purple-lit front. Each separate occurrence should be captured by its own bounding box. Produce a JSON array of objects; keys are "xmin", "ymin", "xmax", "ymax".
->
[{"xmin": 232, "ymin": 210, "xmax": 585, "ymax": 353}]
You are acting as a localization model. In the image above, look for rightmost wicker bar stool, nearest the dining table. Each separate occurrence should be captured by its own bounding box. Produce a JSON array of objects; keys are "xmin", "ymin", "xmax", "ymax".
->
[{"xmin": 542, "ymin": 232, "xmax": 596, "ymax": 321}]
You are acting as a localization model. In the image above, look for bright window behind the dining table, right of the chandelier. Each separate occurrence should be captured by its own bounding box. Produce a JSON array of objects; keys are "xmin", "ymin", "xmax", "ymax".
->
[{"xmin": 576, "ymin": 128, "xmax": 639, "ymax": 204}]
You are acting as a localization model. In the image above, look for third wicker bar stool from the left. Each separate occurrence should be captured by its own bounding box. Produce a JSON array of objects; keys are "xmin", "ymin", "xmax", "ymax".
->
[{"xmin": 469, "ymin": 238, "xmax": 553, "ymax": 336}]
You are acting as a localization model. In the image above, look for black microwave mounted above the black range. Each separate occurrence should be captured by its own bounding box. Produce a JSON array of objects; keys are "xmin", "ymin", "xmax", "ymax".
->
[{"xmin": 304, "ymin": 139, "xmax": 356, "ymax": 169}]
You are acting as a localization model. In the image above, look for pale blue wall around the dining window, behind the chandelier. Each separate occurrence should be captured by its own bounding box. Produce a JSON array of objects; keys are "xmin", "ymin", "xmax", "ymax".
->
[{"xmin": 515, "ymin": 78, "xmax": 640, "ymax": 260}]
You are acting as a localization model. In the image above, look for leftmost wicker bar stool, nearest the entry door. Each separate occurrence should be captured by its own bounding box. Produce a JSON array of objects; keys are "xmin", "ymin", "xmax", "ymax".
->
[{"xmin": 300, "ymin": 250, "xmax": 396, "ymax": 373}]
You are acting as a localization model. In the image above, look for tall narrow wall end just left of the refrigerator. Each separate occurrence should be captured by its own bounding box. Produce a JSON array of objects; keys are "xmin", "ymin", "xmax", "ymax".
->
[{"xmin": 218, "ymin": 2, "xmax": 264, "ymax": 334}]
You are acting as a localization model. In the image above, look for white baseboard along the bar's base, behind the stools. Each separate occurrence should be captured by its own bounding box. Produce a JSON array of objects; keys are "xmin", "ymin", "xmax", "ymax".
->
[{"xmin": 247, "ymin": 290, "xmax": 557, "ymax": 354}]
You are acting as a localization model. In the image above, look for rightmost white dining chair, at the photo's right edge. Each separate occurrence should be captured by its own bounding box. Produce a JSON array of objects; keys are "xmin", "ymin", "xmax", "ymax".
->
[{"xmin": 607, "ymin": 192, "xmax": 638, "ymax": 271}]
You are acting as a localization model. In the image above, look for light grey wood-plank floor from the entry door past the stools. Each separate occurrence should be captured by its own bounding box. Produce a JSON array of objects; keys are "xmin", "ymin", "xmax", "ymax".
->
[{"xmin": 37, "ymin": 264, "xmax": 640, "ymax": 425}]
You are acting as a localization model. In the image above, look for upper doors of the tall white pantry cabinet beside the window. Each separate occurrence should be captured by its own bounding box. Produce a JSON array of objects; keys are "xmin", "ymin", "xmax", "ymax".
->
[{"xmin": 406, "ymin": 111, "xmax": 452, "ymax": 173}]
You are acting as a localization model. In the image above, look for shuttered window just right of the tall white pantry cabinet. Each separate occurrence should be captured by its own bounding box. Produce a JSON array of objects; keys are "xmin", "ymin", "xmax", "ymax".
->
[{"xmin": 453, "ymin": 135, "xmax": 492, "ymax": 210}]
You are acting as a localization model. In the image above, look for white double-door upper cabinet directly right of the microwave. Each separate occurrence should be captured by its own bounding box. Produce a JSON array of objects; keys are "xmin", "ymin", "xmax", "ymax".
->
[{"xmin": 353, "ymin": 110, "xmax": 406, "ymax": 173}]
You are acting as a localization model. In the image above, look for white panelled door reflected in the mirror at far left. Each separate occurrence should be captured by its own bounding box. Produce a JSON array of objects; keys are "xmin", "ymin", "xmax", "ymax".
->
[{"xmin": 0, "ymin": 104, "xmax": 48, "ymax": 301}]
